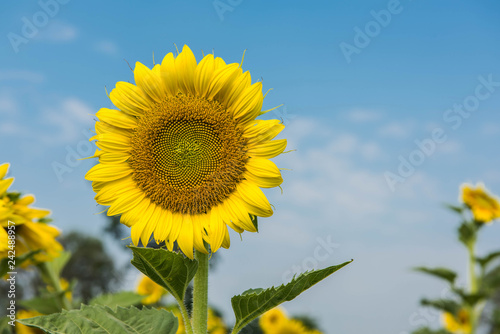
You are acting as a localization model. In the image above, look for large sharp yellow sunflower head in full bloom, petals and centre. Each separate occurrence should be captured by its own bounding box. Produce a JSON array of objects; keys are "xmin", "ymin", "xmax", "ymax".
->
[{"xmin": 86, "ymin": 46, "xmax": 286, "ymax": 258}]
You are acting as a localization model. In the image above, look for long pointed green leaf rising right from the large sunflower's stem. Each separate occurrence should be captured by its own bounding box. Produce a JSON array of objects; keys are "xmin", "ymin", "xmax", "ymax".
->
[{"xmin": 231, "ymin": 260, "xmax": 352, "ymax": 332}]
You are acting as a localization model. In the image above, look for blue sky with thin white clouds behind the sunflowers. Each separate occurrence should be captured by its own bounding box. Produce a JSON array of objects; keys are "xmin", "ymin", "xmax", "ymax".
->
[{"xmin": 0, "ymin": 0, "xmax": 500, "ymax": 334}]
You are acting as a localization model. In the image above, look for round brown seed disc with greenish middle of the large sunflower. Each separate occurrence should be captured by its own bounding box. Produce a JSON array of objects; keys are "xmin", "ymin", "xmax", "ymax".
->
[{"xmin": 129, "ymin": 95, "xmax": 247, "ymax": 214}]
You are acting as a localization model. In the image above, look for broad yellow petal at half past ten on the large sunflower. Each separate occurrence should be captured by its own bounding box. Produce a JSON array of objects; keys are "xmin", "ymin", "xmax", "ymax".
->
[{"xmin": 109, "ymin": 81, "xmax": 151, "ymax": 116}]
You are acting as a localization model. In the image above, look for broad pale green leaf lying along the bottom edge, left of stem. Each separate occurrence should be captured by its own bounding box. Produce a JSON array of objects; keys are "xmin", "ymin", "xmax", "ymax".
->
[{"xmin": 18, "ymin": 305, "xmax": 178, "ymax": 334}]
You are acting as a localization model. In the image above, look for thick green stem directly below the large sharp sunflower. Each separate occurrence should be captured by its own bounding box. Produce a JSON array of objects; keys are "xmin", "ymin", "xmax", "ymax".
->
[{"xmin": 193, "ymin": 251, "xmax": 208, "ymax": 334}]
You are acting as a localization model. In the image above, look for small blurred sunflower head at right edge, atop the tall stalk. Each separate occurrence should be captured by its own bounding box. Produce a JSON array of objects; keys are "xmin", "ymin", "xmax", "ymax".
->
[{"xmin": 461, "ymin": 183, "xmax": 500, "ymax": 223}]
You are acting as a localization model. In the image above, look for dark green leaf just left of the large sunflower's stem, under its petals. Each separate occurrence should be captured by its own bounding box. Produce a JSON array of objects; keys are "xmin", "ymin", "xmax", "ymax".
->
[{"xmin": 129, "ymin": 246, "xmax": 198, "ymax": 302}]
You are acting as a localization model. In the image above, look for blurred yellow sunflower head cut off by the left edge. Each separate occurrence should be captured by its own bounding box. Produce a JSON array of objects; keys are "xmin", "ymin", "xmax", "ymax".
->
[{"xmin": 0, "ymin": 163, "xmax": 63, "ymax": 267}]
